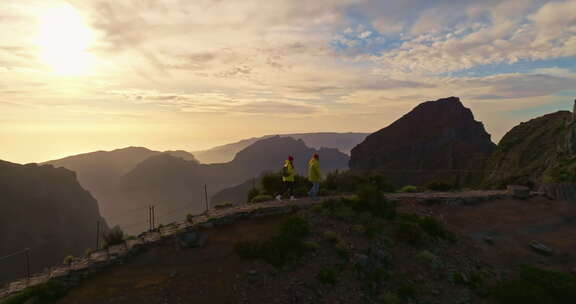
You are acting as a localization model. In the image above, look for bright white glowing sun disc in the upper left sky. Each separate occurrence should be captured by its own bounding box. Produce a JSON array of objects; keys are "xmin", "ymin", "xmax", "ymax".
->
[{"xmin": 37, "ymin": 4, "xmax": 94, "ymax": 75}]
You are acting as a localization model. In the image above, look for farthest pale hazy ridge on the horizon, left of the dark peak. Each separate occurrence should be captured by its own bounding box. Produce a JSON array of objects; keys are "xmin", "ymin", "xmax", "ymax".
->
[{"xmin": 192, "ymin": 132, "xmax": 369, "ymax": 164}]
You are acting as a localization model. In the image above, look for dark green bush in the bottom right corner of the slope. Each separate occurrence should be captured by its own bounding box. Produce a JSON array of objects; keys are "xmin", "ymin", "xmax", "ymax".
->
[{"xmin": 492, "ymin": 266, "xmax": 576, "ymax": 304}]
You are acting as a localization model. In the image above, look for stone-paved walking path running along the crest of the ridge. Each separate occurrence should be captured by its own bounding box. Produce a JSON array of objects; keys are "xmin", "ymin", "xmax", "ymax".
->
[{"xmin": 0, "ymin": 191, "xmax": 506, "ymax": 299}]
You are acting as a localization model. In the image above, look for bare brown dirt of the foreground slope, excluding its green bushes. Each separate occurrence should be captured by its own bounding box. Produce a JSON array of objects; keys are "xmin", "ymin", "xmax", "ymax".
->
[{"xmin": 58, "ymin": 197, "xmax": 576, "ymax": 304}]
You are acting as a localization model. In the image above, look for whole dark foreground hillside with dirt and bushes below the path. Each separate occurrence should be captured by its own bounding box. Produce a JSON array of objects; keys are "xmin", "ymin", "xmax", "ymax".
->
[{"xmin": 5, "ymin": 193, "xmax": 576, "ymax": 304}]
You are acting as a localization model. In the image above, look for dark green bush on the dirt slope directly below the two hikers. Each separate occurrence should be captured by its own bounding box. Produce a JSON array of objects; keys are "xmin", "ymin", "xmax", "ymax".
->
[{"xmin": 236, "ymin": 217, "xmax": 310, "ymax": 267}]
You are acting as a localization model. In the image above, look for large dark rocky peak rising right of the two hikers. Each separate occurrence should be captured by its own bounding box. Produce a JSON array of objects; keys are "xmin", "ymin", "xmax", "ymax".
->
[{"xmin": 350, "ymin": 97, "xmax": 495, "ymax": 186}]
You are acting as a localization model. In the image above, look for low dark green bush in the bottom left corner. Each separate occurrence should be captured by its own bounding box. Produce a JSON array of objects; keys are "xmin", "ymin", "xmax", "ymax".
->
[{"xmin": 2, "ymin": 280, "xmax": 66, "ymax": 304}]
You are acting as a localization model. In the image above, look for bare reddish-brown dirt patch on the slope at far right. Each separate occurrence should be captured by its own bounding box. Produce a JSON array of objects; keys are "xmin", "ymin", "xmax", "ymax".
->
[{"xmin": 401, "ymin": 197, "xmax": 576, "ymax": 271}]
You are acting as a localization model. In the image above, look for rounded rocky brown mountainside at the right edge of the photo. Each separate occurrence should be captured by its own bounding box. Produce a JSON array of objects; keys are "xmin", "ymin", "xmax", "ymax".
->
[{"xmin": 484, "ymin": 111, "xmax": 576, "ymax": 188}]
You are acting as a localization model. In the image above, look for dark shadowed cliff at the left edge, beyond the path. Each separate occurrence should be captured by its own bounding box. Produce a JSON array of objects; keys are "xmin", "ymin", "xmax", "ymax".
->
[{"xmin": 0, "ymin": 161, "xmax": 100, "ymax": 281}]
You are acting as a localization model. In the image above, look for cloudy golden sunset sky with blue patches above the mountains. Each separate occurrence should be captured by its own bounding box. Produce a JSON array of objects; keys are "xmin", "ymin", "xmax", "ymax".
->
[{"xmin": 0, "ymin": 0, "xmax": 576, "ymax": 163}]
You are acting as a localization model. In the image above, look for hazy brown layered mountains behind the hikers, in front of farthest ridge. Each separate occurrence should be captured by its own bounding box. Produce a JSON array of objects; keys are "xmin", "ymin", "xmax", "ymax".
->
[{"xmin": 47, "ymin": 136, "xmax": 349, "ymax": 233}]
